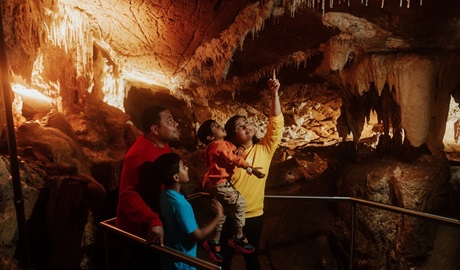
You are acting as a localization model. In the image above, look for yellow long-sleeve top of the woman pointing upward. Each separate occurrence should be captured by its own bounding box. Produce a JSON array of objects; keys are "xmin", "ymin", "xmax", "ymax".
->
[{"xmin": 232, "ymin": 114, "xmax": 284, "ymax": 218}]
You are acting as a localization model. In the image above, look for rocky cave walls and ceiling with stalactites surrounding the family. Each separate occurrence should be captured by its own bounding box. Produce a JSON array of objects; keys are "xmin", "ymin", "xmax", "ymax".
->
[{"xmin": 0, "ymin": 0, "xmax": 460, "ymax": 269}]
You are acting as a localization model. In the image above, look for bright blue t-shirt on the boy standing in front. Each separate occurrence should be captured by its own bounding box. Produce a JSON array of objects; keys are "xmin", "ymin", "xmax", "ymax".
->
[{"xmin": 160, "ymin": 189, "xmax": 198, "ymax": 270}]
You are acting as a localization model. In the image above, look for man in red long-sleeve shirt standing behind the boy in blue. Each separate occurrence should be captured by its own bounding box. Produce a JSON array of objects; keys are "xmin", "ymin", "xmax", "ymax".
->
[{"xmin": 116, "ymin": 105, "xmax": 180, "ymax": 266}]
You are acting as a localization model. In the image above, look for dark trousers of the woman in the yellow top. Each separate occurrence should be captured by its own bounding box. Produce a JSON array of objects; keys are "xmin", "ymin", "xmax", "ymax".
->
[{"xmin": 219, "ymin": 215, "xmax": 264, "ymax": 270}]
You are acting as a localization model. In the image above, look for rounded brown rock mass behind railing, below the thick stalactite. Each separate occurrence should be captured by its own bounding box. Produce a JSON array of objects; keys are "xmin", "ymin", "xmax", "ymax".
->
[{"xmin": 336, "ymin": 155, "xmax": 452, "ymax": 269}]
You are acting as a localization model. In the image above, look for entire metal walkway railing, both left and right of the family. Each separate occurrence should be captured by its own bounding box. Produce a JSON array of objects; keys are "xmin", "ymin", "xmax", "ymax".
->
[{"xmin": 100, "ymin": 192, "xmax": 460, "ymax": 270}]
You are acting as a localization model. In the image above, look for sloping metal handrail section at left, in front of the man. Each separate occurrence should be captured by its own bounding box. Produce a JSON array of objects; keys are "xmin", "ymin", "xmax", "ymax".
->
[{"xmin": 99, "ymin": 217, "xmax": 221, "ymax": 270}]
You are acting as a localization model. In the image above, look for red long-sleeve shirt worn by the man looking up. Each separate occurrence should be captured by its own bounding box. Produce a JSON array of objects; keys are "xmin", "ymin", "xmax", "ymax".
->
[{"xmin": 116, "ymin": 136, "xmax": 171, "ymax": 238}]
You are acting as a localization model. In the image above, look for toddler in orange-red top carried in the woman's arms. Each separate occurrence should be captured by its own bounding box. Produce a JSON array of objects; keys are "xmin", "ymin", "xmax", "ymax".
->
[{"xmin": 197, "ymin": 120, "xmax": 265, "ymax": 262}]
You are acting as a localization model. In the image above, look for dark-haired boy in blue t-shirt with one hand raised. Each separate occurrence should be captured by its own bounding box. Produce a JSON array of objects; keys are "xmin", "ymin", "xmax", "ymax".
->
[{"xmin": 142, "ymin": 153, "xmax": 224, "ymax": 270}]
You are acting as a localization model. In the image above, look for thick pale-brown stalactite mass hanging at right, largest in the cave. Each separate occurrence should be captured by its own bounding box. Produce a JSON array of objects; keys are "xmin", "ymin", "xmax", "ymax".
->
[{"xmin": 339, "ymin": 54, "xmax": 438, "ymax": 150}]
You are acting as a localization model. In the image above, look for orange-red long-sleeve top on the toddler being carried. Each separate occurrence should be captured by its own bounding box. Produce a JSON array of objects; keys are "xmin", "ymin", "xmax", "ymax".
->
[{"xmin": 202, "ymin": 140, "xmax": 249, "ymax": 187}]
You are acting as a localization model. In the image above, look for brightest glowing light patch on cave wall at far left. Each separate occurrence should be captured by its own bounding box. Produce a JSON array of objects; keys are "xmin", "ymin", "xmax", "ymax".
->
[{"xmin": 11, "ymin": 84, "xmax": 52, "ymax": 112}]
